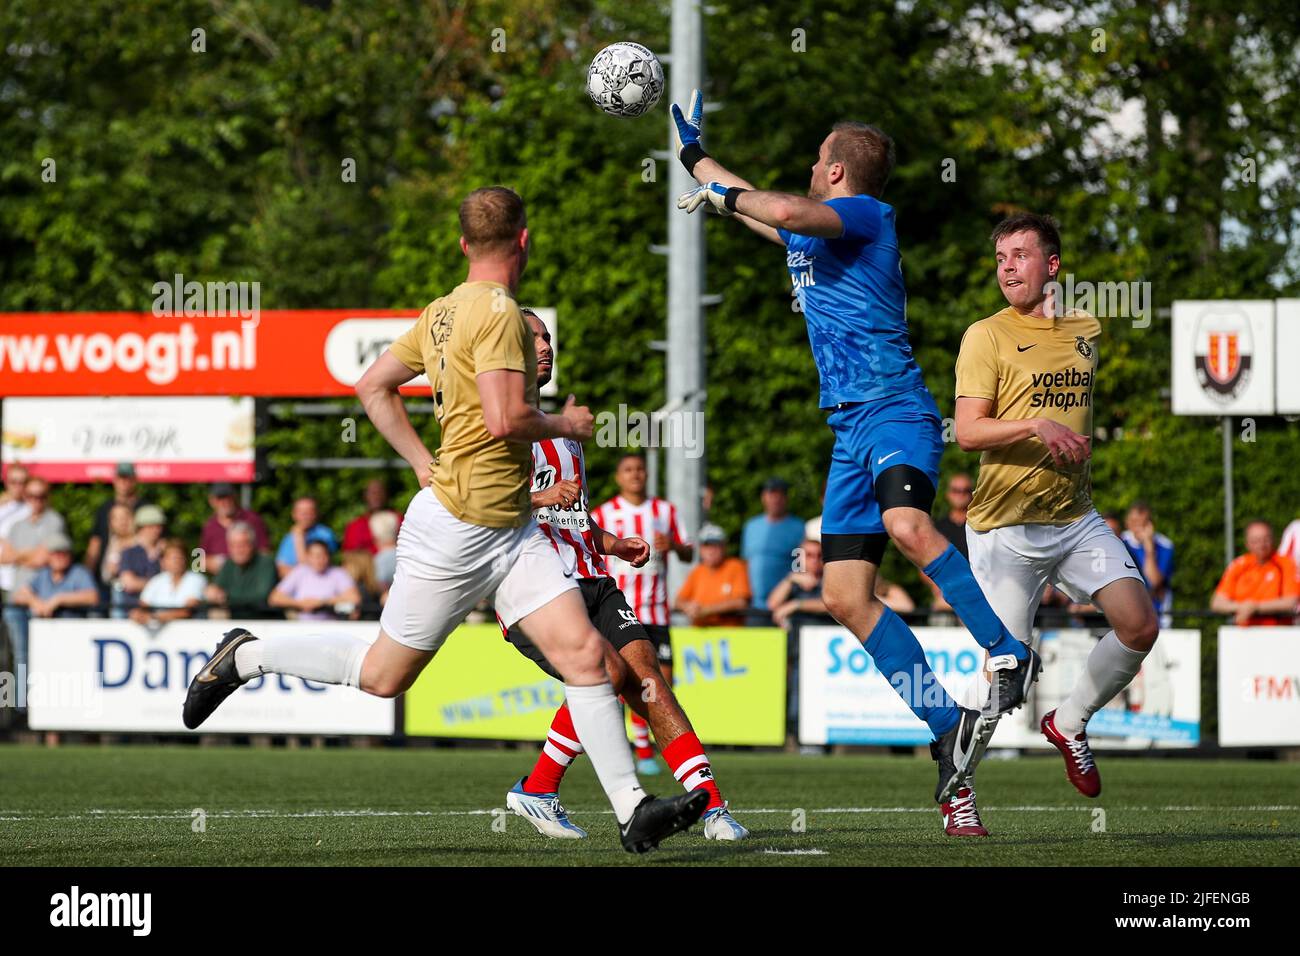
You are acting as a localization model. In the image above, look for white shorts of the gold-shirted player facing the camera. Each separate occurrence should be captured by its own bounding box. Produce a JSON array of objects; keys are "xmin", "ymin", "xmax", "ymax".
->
[{"xmin": 966, "ymin": 511, "xmax": 1143, "ymax": 644}]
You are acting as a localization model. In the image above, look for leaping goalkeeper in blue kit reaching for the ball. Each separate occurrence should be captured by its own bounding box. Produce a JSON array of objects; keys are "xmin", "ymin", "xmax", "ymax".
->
[{"xmin": 671, "ymin": 90, "xmax": 1040, "ymax": 836}]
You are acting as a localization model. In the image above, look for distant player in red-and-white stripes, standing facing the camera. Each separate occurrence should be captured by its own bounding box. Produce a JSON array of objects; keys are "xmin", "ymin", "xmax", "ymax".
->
[{"xmin": 592, "ymin": 451, "xmax": 696, "ymax": 774}]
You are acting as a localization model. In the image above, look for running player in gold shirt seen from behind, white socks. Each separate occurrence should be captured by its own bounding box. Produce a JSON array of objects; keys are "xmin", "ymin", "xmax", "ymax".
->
[{"xmin": 183, "ymin": 186, "xmax": 709, "ymax": 852}]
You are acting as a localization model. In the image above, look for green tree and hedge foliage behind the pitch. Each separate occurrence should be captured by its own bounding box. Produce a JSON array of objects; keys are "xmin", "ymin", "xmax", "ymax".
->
[{"xmin": 0, "ymin": 0, "xmax": 1300, "ymax": 621}]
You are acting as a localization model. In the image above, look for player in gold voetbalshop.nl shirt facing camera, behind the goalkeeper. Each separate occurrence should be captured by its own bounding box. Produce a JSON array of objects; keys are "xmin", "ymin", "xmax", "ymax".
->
[{"xmin": 957, "ymin": 213, "xmax": 1158, "ymax": 797}]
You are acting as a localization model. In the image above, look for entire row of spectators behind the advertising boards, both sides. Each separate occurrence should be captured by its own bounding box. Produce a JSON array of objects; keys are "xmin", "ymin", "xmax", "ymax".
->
[{"xmin": 0, "ymin": 463, "xmax": 1300, "ymax": 686}]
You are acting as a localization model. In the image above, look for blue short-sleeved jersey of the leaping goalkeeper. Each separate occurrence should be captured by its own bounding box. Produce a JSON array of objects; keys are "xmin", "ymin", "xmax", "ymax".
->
[{"xmin": 777, "ymin": 195, "xmax": 926, "ymax": 408}]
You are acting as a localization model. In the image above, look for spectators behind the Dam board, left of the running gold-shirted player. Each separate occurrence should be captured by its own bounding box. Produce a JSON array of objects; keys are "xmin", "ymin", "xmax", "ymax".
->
[{"xmin": 0, "ymin": 463, "xmax": 402, "ymax": 669}]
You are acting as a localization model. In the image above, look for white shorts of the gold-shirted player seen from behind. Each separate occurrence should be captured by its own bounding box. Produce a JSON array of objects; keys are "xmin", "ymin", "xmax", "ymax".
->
[{"xmin": 380, "ymin": 488, "xmax": 577, "ymax": 652}]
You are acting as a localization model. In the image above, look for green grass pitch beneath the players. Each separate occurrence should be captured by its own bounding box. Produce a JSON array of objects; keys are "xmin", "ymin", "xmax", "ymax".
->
[{"xmin": 0, "ymin": 745, "xmax": 1300, "ymax": 866}]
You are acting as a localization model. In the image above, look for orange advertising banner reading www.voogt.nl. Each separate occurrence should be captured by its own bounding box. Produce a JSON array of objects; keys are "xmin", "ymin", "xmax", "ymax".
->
[{"xmin": 0, "ymin": 308, "xmax": 428, "ymax": 397}]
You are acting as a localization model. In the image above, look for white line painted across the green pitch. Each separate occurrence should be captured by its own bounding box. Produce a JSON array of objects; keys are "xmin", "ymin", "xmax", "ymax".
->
[{"xmin": 0, "ymin": 804, "xmax": 1300, "ymax": 822}]
